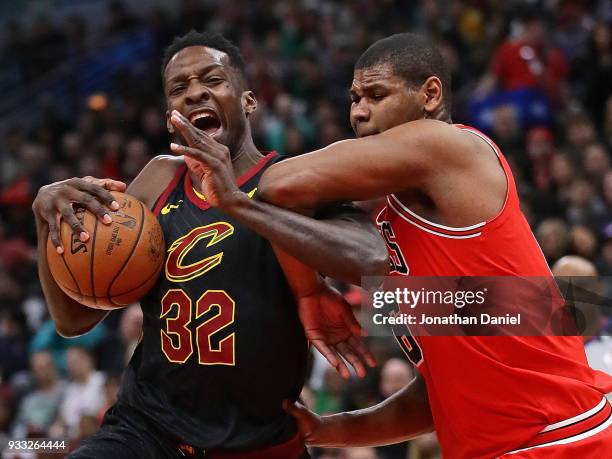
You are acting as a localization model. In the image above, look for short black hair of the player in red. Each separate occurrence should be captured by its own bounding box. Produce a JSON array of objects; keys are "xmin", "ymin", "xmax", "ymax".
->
[{"xmin": 355, "ymin": 33, "xmax": 451, "ymax": 110}]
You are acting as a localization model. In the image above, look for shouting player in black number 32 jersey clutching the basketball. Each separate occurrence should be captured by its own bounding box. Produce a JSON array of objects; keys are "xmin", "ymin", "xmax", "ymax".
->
[{"xmin": 33, "ymin": 33, "xmax": 388, "ymax": 459}]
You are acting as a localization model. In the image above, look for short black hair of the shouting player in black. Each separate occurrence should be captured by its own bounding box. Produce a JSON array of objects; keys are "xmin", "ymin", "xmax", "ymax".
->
[{"xmin": 161, "ymin": 30, "xmax": 246, "ymax": 83}]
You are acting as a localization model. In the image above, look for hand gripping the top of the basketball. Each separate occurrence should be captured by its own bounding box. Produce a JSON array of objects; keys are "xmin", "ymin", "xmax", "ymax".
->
[{"xmin": 32, "ymin": 177, "xmax": 126, "ymax": 254}]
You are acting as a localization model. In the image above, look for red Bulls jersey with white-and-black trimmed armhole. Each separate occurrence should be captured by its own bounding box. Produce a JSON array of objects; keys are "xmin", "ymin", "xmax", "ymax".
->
[{"xmin": 377, "ymin": 125, "xmax": 612, "ymax": 459}]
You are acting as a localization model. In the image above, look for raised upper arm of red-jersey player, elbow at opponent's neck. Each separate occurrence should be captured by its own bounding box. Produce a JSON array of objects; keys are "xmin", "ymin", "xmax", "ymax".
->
[{"xmin": 258, "ymin": 120, "xmax": 474, "ymax": 209}]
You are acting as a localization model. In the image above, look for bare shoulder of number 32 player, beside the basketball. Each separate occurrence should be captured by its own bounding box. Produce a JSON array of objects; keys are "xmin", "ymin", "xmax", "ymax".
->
[{"xmin": 127, "ymin": 155, "xmax": 185, "ymax": 208}]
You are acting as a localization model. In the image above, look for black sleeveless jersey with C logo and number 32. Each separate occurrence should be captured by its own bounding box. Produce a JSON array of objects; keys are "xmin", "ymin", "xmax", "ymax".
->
[{"xmin": 119, "ymin": 154, "xmax": 308, "ymax": 451}]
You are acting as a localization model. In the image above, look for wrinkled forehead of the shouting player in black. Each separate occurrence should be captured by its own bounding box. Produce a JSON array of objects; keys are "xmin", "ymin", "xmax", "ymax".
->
[{"xmin": 164, "ymin": 46, "xmax": 231, "ymax": 82}]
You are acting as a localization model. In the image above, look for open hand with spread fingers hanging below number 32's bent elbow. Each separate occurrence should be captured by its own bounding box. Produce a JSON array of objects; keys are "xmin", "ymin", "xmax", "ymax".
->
[{"xmin": 298, "ymin": 283, "xmax": 376, "ymax": 378}]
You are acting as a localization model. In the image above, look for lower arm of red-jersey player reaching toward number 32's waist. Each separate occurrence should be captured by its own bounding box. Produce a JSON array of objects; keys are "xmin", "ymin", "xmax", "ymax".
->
[{"xmin": 285, "ymin": 376, "xmax": 433, "ymax": 448}]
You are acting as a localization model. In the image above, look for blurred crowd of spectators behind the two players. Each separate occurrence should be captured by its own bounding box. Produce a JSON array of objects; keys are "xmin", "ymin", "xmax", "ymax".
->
[{"xmin": 0, "ymin": 0, "xmax": 612, "ymax": 459}]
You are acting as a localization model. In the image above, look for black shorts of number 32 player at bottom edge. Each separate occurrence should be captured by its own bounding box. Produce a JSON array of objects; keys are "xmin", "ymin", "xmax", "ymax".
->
[{"xmin": 67, "ymin": 406, "xmax": 310, "ymax": 459}]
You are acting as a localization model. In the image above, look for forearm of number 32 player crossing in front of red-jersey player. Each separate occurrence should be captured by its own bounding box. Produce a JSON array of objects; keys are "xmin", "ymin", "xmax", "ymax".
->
[{"xmin": 225, "ymin": 199, "xmax": 388, "ymax": 284}]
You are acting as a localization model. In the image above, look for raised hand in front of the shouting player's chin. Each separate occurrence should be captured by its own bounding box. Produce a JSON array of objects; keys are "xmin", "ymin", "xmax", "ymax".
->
[{"xmin": 170, "ymin": 110, "xmax": 247, "ymax": 208}]
